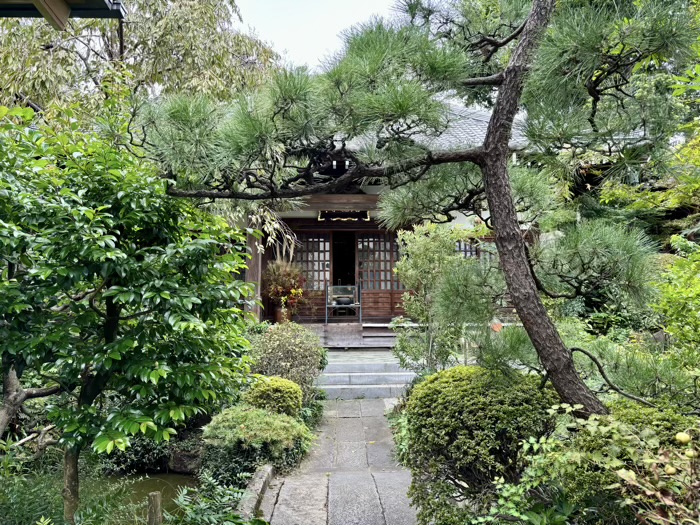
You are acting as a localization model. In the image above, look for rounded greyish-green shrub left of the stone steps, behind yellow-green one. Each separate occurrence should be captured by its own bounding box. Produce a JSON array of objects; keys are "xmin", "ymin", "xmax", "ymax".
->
[{"xmin": 251, "ymin": 323, "xmax": 326, "ymax": 405}]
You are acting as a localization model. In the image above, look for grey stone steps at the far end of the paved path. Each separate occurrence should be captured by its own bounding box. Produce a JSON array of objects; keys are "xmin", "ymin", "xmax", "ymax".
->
[{"xmin": 317, "ymin": 358, "xmax": 415, "ymax": 399}]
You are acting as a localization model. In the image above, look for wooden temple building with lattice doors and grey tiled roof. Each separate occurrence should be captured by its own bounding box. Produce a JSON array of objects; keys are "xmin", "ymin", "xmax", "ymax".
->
[{"xmin": 247, "ymin": 104, "xmax": 525, "ymax": 347}]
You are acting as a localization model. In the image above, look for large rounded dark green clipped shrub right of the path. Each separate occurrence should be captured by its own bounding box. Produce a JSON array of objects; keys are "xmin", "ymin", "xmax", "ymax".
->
[{"xmin": 405, "ymin": 366, "xmax": 557, "ymax": 525}]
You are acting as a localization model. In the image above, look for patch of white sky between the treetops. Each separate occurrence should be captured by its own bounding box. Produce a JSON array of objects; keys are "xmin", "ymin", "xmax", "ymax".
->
[{"xmin": 236, "ymin": 0, "xmax": 394, "ymax": 68}]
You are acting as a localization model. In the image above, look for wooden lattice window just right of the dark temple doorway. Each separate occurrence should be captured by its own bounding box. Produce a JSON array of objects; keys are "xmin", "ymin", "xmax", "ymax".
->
[{"xmin": 357, "ymin": 233, "xmax": 400, "ymax": 290}]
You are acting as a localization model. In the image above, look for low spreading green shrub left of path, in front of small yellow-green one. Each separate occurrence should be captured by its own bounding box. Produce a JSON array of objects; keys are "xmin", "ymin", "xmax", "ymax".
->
[{"xmin": 202, "ymin": 404, "xmax": 313, "ymax": 486}]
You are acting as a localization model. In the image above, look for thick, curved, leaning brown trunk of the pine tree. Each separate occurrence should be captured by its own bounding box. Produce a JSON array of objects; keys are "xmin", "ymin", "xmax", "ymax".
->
[{"xmin": 481, "ymin": 0, "xmax": 607, "ymax": 414}]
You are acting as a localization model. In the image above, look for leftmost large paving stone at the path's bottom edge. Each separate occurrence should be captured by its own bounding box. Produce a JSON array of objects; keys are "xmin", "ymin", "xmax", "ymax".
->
[{"xmin": 270, "ymin": 473, "xmax": 328, "ymax": 525}]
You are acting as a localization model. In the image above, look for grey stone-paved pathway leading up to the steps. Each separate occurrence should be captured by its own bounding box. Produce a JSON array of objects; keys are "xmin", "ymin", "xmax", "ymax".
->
[{"xmin": 261, "ymin": 399, "xmax": 416, "ymax": 525}]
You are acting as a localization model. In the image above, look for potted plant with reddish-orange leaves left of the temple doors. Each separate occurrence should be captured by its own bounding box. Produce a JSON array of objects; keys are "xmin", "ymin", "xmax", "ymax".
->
[{"xmin": 262, "ymin": 260, "xmax": 306, "ymax": 323}]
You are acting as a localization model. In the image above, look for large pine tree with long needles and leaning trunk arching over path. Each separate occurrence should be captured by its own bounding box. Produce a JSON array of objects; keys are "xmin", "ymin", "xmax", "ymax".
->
[{"xmin": 149, "ymin": 0, "xmax": 697, "ymax": 413}]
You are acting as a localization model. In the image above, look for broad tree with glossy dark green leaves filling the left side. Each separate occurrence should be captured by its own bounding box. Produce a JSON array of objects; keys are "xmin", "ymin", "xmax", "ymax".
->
[{"xmin": 0, "ymin": 108, "xmax": 250, "ymax": 523}]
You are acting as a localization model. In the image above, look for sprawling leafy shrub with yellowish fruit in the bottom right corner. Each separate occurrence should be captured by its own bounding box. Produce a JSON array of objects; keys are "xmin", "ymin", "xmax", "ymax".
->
[{"xmin": 480, "ymin": 401, "xmax": 698, "ymax": 525}]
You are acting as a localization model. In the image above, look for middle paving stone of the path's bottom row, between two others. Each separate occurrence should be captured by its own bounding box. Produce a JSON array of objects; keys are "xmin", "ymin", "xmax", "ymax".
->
[{"xmin": 330, "ymin": 472, "xmax": 385, "ymax": 525}]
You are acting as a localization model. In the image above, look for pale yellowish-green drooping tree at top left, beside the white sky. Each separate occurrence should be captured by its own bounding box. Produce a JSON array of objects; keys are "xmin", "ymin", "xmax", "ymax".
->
[{"xmin": 0, "ymin": 0, "xmax": 275, "ymax": 111}]
